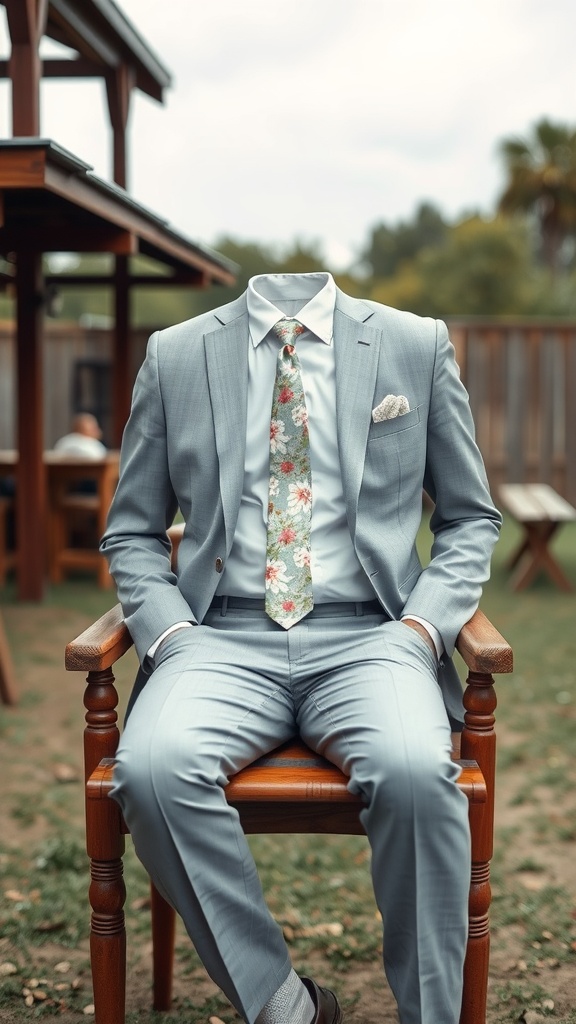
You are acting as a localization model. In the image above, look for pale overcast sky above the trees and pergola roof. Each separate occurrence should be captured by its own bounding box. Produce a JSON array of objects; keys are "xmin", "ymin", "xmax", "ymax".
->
[{"xmin": 0, "ymin": 0, "xmax": 576, "ymax": 265}]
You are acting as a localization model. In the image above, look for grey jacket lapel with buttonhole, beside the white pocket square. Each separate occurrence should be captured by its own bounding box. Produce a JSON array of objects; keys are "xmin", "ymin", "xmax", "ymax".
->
[{"xmin": 334, "ymin": 290, "xmax": 381, "ymax": 537}]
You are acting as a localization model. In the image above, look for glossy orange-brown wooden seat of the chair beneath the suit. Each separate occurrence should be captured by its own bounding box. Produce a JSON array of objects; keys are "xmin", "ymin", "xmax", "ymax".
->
[{"xmin": 86, "ymin": 740, "xmax": 487, "ymax": 835}]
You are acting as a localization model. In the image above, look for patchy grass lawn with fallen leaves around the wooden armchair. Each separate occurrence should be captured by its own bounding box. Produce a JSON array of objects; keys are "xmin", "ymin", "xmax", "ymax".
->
[{"xmin": 0, "ymin": 522, "xmax": 576, "ymax": 1024}]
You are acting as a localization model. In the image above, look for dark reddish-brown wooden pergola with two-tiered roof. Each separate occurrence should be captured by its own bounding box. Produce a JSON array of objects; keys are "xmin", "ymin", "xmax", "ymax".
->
[{"xmin": 0, "ymin": 0, "xmax": 235, "ymax": 601}]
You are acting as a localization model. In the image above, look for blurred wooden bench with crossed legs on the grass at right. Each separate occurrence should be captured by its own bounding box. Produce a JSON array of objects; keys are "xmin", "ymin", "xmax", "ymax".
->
[{"xmin": 499, "ymin": 483, "xmax": 576, "ymax": 592}]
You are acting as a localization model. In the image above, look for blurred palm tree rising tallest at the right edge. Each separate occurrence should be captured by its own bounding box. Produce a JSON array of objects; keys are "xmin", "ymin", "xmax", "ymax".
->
[{"xmin": 499, "ymin": 118, "xmax": 576, "ymax": 272}]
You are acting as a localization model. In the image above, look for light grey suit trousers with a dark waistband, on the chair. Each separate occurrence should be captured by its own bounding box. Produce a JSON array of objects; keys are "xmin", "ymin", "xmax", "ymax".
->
[{"xmin": 109, "ymin": 609, "xmax": 469, "ymax": 1024}]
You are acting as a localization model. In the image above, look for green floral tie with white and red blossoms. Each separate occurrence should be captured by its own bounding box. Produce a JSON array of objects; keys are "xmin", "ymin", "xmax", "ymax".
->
[{"xmin": 265, "ymin": 319, "xmax": 314, "ymax": 630}]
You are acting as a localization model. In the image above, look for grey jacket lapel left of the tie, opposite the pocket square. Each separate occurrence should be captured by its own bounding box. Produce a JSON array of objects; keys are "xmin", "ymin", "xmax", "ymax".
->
[{"xmin": 204, "ymin": 302, "xmax": 248, "ymax": 550}]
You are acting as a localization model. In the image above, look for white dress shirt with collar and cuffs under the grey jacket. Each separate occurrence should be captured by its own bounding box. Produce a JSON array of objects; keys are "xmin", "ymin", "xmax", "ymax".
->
[{"xmin": 149, "ymin": 272, "xmax": 443, "ymax": 656}]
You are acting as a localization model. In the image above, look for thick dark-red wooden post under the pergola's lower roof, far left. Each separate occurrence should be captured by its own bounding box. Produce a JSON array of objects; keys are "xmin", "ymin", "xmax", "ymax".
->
[{"xmin": 16, "ymin": 252, "xmax": 46, "ymax": 601}]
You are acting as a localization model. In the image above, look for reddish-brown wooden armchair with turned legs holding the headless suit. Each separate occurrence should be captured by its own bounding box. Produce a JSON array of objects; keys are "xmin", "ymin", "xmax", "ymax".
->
[{"xmin": 66, "ymin": 528, "xmax": 512, "ymax": 1024}]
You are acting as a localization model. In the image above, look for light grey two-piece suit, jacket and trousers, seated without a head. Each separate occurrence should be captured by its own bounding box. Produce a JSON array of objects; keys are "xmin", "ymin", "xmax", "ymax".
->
[{"xmin": 102, "ymin": 291, "xmax": 500, "ymax": 1024}]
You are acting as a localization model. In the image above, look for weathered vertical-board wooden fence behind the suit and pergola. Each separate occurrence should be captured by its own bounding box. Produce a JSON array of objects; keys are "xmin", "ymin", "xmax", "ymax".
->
[{"xmin": 0, "ymin": 319, "xmax": 576, "ymax": 504}]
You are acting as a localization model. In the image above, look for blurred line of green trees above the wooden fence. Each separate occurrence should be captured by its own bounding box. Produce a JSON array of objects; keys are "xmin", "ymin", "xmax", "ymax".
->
[{"xmin": 0, "ymin": 119, "xmax": 576, "ymax": 326}]
